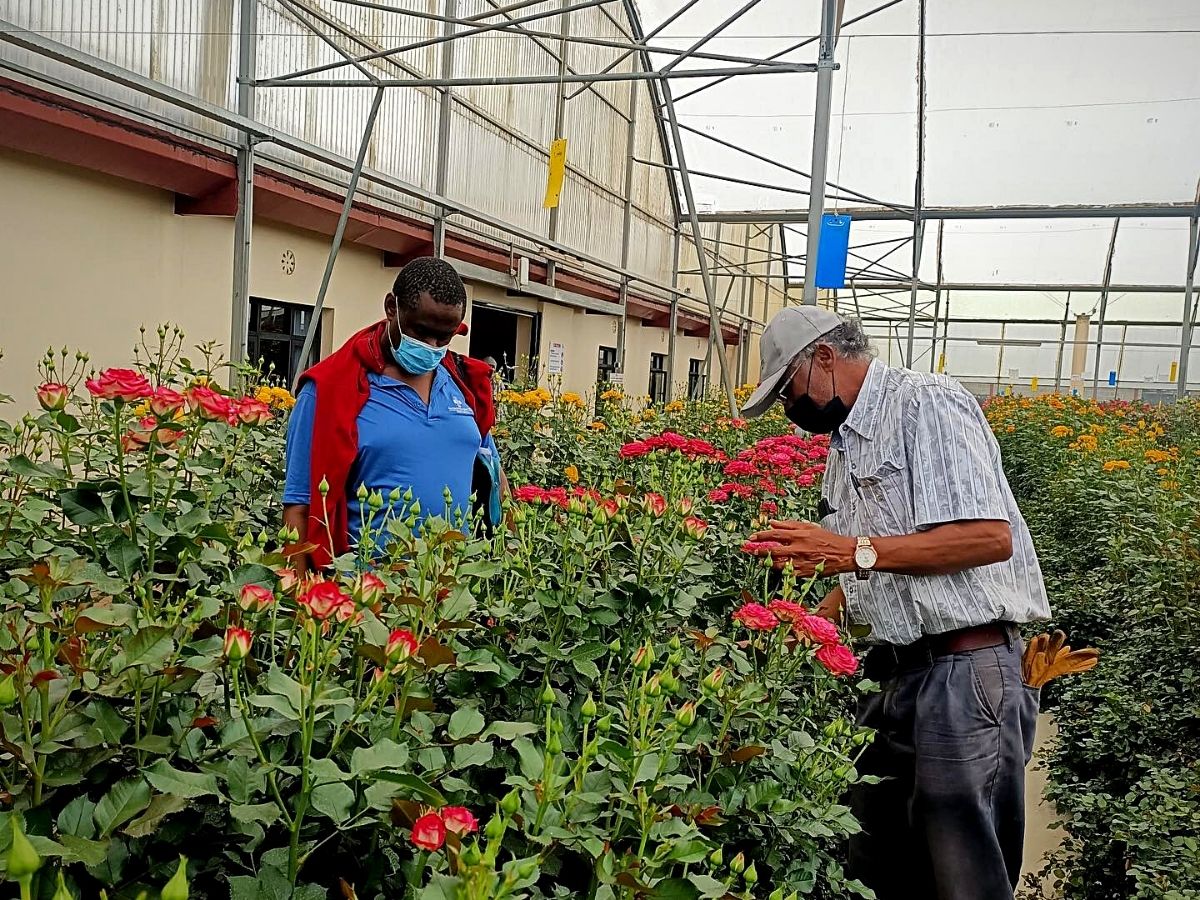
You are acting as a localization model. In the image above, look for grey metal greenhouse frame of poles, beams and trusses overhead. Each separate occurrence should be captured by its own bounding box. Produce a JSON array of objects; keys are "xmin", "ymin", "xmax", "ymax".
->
[{"xmin": 0, "ymin": 0, "xmax": 1200, "ymax": 410}]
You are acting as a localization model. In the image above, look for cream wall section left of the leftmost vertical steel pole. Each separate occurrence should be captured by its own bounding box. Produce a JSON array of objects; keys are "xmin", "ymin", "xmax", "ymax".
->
[{"xmin": 0, "ymin": 151, "xmax": 233, "ymax": 409}]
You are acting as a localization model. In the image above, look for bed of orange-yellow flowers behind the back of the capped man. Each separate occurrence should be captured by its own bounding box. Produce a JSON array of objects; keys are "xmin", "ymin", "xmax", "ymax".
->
[{"xmin": 988, "ymin": 397, "xmax": 1200, "ymax": 900}]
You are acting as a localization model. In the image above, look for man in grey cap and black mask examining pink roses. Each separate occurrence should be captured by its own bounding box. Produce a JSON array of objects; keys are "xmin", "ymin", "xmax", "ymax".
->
[{"xmin": 743, "ymin": 306, "xmax": 1050, "ymax": 900}]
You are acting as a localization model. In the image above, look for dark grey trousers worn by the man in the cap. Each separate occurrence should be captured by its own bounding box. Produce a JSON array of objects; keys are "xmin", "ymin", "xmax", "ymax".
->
[{"xmin": 850, "ymin": 636, "xmax": 1038, "ymax": 900}]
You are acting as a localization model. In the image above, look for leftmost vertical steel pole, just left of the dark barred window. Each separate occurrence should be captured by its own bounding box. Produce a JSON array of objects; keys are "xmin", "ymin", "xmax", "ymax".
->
[{"xmin": 229, "ymin": 0, "xmax": 258, "ymax": 362}]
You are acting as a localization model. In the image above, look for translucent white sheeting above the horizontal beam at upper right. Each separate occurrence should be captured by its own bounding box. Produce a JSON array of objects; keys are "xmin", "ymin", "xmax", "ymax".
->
[{"xmin": 640, "ymin": 0, "xmax": 1200, "ymax": 210}]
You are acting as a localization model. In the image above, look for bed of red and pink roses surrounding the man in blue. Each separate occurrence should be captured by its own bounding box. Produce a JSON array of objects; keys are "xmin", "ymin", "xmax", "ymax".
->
[{"xmin": 0, "ymin": 329, "xmax": 869, "ymax": 900}]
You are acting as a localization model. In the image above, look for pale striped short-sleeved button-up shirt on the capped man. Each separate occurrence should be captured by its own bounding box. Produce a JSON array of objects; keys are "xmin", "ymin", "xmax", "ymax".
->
[{"xmin": 822, "ymin": 360, "xmax": 1050, "ymax": 644}]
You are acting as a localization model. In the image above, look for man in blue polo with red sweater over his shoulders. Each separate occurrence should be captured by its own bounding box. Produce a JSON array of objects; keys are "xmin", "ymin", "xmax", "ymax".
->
[{"xmin": 283, "ymin": 257, "xmax": 503, "ymax": 568}]
